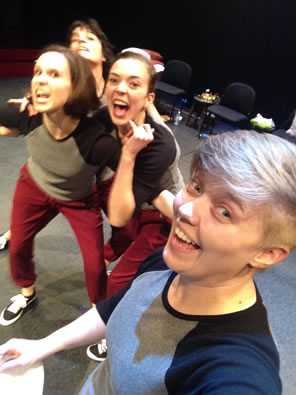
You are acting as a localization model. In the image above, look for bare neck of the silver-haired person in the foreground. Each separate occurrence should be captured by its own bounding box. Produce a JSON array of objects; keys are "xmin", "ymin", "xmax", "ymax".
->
[{"xmin": 168, "ymin": 274, "xmax": 256, "ymax": 315}]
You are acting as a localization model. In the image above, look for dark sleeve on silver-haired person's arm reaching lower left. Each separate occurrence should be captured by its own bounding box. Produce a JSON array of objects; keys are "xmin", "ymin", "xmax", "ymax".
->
[{"xmin": 96, "ymin": 248, "xmax": 168, "ymax": 324}]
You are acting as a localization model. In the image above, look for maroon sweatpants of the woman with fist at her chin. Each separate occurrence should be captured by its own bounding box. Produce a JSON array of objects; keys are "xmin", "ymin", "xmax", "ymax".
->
[{"xmin": 104, "ymin": 210, "xmax": 171, "ymax": 297}]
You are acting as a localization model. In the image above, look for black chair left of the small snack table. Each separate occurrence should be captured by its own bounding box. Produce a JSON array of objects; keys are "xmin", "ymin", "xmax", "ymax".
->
[{"xmin": 156, "ymin": 59, "xmax": 192, "ymax": 117}]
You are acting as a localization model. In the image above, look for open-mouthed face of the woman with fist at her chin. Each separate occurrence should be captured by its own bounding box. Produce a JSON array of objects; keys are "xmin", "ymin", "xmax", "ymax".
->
[{"xmin": 106, "ymin": 58, "xmax": 154, "ymax": 127}]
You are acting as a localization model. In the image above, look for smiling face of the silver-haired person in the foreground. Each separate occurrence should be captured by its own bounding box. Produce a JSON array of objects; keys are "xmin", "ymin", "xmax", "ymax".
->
[{"xmin": 164, "ymin": 173, "xmax": 264, "ymax": 287}]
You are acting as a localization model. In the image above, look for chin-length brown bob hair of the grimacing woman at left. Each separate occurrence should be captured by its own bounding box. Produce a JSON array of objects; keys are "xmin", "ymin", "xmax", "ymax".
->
[{"xmin": 40, "ymin": 44, "xmax": 100, "ymax": 118}]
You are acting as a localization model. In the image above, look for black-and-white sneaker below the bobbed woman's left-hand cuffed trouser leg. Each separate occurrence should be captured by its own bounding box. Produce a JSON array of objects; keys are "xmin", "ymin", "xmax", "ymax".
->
[{"xmin": 0, "ymin": 292, "xmax": 36, "ymax": 326}]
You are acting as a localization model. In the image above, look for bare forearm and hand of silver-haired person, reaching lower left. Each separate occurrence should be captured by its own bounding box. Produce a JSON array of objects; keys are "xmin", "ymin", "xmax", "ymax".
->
[{"xmin": 0, "ymin": 307, "xmax": 106, "ymax": 373}]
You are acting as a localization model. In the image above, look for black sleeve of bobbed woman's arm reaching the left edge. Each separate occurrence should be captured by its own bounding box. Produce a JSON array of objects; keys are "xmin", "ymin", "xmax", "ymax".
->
[{"xmin": 0, "ymin": 103, "xmax": 42, "ymax": 135}]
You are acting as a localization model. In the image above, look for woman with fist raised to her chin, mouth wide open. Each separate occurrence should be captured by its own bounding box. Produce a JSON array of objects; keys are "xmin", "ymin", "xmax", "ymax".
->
[{"xmin": 87, "ymin": 51, "xmax": 183, "ymax": 361}]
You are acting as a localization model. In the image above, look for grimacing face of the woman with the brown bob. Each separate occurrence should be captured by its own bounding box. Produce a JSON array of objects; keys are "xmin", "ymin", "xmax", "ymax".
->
[{"xmin": 31, "ymin": 52, "xmax": 72, "ymax": 113}]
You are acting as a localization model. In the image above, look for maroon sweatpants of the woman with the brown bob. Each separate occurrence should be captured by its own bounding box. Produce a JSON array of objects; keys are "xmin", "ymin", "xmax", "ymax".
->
[{"xmin": 9, "ymin": 164, "xmax": 107, "ymax": 303}]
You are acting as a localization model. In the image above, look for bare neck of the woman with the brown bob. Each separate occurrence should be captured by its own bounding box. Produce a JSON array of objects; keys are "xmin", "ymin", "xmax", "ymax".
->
[{"xmin": 42, "ymin": 111, "xmax": 80, "ymax": 140}]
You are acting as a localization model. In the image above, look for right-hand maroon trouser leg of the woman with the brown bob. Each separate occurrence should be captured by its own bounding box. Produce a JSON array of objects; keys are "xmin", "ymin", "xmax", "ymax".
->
[{"xmin": 60, "ymin": 191, "xmax": 107, "ymax": 303}]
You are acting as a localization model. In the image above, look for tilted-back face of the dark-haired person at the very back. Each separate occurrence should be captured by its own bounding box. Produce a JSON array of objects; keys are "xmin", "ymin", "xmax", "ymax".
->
[{"xmin": 70, "ymin": 27, "xmax": 106, "ymax": 64}]
